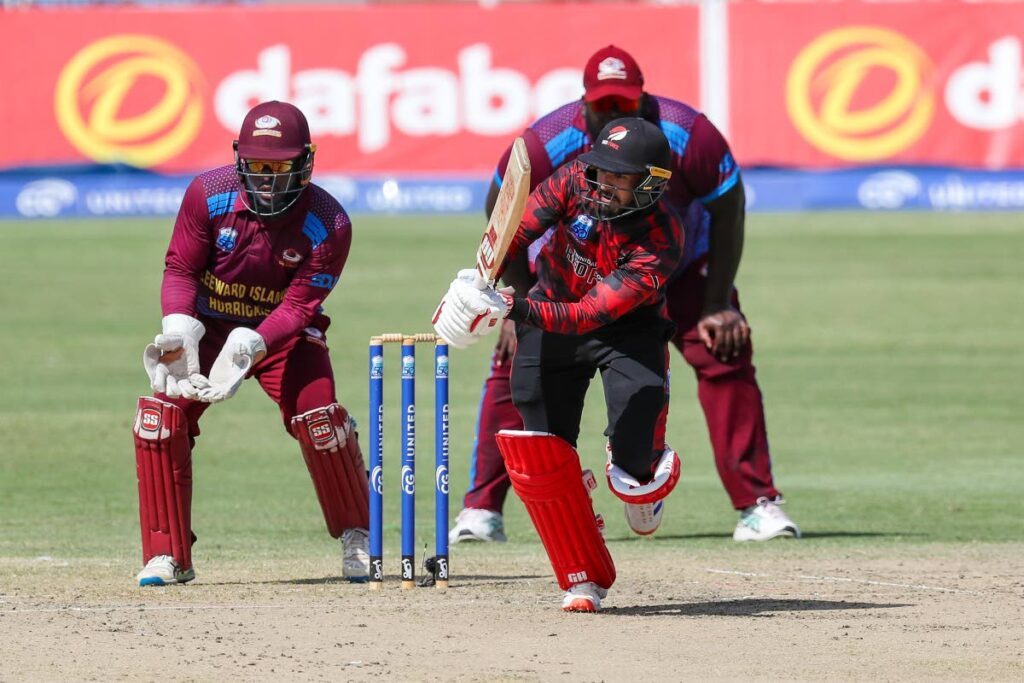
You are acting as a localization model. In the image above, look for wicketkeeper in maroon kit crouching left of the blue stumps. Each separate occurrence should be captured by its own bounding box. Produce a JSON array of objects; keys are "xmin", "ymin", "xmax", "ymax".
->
[{"xmin": 134, "ymin": 101, "xmax": 370, "ymax": 586}]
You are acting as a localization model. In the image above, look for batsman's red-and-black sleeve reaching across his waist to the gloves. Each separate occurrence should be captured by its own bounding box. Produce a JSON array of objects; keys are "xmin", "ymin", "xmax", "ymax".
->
[{"xmin": 510, "ymin": 214, "xmax": 683, "ymax": 335}]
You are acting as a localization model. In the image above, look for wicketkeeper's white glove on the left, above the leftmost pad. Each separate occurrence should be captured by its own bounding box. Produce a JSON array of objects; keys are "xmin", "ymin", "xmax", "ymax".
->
[{"xmin": 142, "ymin": 313, "xmax": 209, "ymax": 400}]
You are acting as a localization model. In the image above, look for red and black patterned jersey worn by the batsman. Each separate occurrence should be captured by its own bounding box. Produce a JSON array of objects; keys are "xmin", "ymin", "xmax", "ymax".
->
[{"xmin": 505, "ymin": 162, "xmax": 683, "ymax": 334}]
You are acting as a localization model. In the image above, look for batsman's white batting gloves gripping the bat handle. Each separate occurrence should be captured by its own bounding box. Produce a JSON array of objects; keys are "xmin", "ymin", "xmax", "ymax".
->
[{"xmin": 433, "ymin": 268, "xmax": 512, "ymax": 348}]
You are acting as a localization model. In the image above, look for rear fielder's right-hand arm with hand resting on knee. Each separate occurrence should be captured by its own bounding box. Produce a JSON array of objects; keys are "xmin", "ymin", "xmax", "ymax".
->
[{"xmin": 683, "ymin": 116, "xmax": 750, "ymax": 360}]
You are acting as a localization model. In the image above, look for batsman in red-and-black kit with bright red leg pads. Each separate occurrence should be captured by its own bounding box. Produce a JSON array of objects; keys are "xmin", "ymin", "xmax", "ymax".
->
[{"xmin": 434, "ymin": 118, "xmax": 684, "ymax": 611}]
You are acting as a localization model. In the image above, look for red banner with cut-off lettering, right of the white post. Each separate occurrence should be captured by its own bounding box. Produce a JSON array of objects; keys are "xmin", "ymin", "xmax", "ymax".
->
[{"xmin": 729, "ymin": 0, "xmax": 1024, "ymax": 169}]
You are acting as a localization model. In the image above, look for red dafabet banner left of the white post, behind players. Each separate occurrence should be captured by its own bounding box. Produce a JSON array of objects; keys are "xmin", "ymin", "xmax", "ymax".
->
[{"xmin": 0, "ymin": 5, "xmax": 699, "ymax": 174}]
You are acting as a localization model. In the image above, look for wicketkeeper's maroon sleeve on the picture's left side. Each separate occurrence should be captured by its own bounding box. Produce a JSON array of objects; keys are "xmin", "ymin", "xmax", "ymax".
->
[{"xmin": 160, "ymin": 177, "xmax": 210, "ymax": 316}]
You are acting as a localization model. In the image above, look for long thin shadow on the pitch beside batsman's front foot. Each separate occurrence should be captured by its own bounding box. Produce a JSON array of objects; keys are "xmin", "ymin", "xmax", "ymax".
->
[{"xmin": 601, "ymin": 598, "xmax": 912, "ymax": 616}]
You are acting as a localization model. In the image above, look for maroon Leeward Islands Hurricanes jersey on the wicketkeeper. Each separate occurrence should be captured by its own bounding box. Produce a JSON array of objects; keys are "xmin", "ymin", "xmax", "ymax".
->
[{"xmin": 161, "ymin": 166, "xmax": 352, "ymax": 352}]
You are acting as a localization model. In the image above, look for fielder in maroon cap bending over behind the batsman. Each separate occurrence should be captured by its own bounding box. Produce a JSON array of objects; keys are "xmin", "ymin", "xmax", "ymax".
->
[{"xmin": 450, "ymin": 45, "xmax": 800, "ymax": 543}]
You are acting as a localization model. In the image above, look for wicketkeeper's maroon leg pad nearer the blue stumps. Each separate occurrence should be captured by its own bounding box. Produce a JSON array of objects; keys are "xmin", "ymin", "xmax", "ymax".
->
[{"xmin": 292, "ymin": 403, "xmax": 370, "ymax": 539}]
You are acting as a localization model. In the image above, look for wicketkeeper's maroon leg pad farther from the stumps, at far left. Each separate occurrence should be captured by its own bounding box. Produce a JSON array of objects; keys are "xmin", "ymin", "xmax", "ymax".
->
[{"xmin": 132, "ymin": 396, "xmax": 191, "ymax": 569}]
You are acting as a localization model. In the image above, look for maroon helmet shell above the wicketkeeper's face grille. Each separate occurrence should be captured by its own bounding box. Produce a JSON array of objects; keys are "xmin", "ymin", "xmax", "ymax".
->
[{"xmin": 239, "ymin": 99, "xmax": 309, "ymax": 161}]
